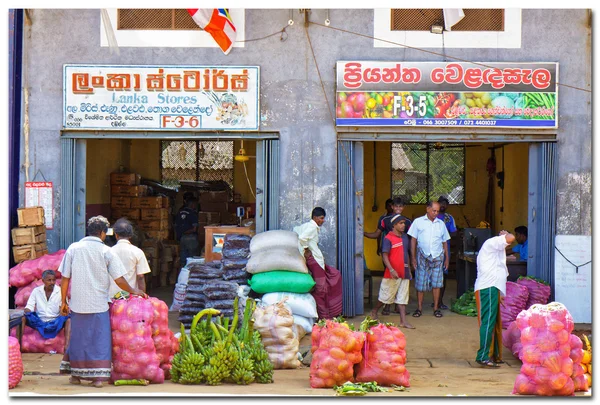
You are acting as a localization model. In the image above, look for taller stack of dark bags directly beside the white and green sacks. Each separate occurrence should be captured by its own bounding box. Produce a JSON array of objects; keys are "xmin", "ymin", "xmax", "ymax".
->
[{"xmin": 221, "ymin": 233, "xmax": 252, "ymax": 285}]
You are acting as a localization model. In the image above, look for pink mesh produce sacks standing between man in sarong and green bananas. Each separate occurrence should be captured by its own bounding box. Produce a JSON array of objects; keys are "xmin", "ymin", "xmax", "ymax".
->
[{"xmin": 110, "ymin": 296, "xmax": 178, "ymax": 384}]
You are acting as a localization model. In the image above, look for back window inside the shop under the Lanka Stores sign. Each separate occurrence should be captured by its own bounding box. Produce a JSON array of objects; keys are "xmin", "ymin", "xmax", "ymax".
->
[{"xmin": 160, "ymin": 141, "xmax": 234, "ymax": 190}]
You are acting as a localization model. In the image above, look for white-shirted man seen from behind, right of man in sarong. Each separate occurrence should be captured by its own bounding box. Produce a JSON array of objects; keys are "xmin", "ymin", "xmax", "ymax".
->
[{"xmin": 108, "ymin": 218, "xmax": 151, "ymax": 298}]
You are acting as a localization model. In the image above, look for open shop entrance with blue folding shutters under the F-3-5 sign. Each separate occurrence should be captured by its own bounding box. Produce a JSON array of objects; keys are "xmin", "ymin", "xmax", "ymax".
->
[{"xmin": 338, "ymin": 134, "xmax": 556, "ymax": 316}]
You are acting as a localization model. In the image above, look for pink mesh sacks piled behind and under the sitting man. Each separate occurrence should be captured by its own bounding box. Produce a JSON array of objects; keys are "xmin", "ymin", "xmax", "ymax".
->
[{"xmin": 9, "ymin": 250, "xmax": 71, "ymax": 353}]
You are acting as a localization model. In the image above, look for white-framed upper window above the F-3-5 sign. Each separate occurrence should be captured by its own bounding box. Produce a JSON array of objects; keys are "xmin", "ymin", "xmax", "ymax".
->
[{"xmin": 373, "ymin": 9, "xmax": 521, "ymax": 48}]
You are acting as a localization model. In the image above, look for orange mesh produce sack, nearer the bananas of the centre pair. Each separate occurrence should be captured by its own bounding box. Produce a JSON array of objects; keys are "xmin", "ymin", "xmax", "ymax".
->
[{"xmin": 310, "ymin": 318, "xmax": 365, "ymax": 388}]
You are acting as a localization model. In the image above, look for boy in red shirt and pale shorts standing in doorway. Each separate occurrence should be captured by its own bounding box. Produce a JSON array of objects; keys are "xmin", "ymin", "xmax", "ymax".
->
[{"xmin": 371, "ymin": 214, "xmax": 414, "ymax": 329}]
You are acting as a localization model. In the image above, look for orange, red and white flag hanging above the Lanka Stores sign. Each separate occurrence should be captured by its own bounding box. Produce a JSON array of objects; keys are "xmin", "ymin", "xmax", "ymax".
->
[{"xmin": 187, "ymin": 8, "xmax": 236, "ymax": 55}]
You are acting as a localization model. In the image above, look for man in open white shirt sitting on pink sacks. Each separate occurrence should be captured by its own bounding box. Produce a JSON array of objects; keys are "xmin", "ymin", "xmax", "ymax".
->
[{"xmin": 23, "ymin": 270, "xmax": 71, "ymax": 350}]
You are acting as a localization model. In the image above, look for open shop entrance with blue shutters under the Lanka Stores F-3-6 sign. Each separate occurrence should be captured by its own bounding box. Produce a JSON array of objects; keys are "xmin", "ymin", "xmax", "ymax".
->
[{"xmin": 60, "ymin": 133, "xmax": 279, "ymax": 296}]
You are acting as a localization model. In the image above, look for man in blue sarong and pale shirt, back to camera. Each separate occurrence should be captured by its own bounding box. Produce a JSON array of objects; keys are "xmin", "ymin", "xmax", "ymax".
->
[{"xmin": 58, "ymin": 216, "xmax": 147, "ymax": 388}]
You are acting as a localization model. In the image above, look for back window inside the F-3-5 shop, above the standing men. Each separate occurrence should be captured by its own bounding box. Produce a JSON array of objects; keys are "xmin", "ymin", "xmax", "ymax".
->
[{"xmin": 391, "ymin": 142, "xmax": 466, "ymax": 204}]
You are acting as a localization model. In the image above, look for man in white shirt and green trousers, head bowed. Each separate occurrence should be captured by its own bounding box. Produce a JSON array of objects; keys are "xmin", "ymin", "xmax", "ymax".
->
[{"xmin": 475, "ymin": 231, "xmax": 515, "ymax": 368}]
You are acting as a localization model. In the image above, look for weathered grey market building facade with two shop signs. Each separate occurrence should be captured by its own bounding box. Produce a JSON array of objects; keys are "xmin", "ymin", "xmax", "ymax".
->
[{"xmin": 10, "ymin": 9, "xmax": 592, "ymax": 322}]
